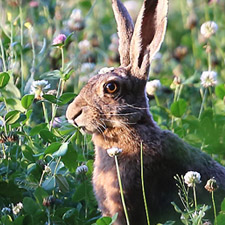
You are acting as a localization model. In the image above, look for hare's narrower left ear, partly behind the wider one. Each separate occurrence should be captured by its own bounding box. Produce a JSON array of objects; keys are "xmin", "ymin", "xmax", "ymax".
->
[{"xmin": 112, "ymin": 0, "xmax": 134, "ymax": 67}]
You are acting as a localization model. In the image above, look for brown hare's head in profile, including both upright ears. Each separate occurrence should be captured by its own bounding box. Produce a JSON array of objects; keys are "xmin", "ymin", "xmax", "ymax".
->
[{"xmin": 66, "ymin": 0, "xmax": 168, "ymax": 133}]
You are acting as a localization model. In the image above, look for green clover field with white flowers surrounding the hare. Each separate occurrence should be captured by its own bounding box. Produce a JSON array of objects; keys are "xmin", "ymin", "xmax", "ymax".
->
[{"xmin": 0, "ymin": 0, "xmax": 225, "ymax": 225}]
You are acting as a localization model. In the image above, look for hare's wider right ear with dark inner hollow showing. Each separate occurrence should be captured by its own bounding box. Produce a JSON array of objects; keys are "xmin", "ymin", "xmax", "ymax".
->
[{"xmin": 130, "ymin": 0, "xmax": 168, "ymax": 80}]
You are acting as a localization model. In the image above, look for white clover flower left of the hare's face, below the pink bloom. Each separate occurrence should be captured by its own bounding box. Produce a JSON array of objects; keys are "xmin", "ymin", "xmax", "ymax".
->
[{"xmin": 30, "ymin": 80, "xmax": 51, "ymax": 100}]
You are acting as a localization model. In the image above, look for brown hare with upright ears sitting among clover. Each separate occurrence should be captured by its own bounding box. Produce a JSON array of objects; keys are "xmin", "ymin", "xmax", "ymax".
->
[{"xmin": 66, "ymin": 0, "xmax": 225, "ymax": 225}]
